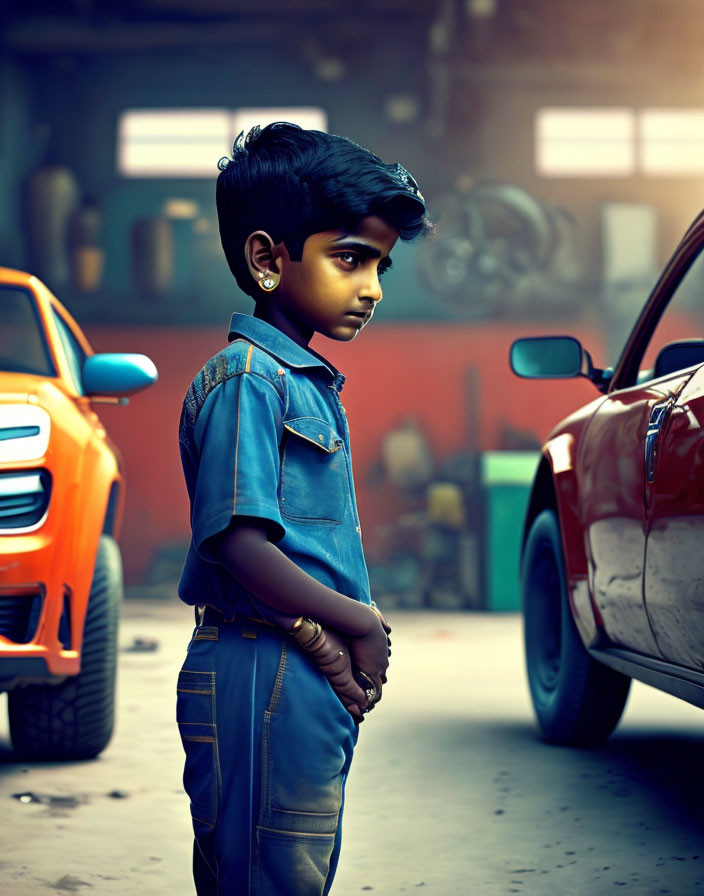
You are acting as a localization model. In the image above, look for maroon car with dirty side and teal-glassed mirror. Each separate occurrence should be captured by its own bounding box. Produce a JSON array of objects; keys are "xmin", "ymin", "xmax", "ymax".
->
[{"xmin": 511, "ymin": 213, "xmax": 704, "ymax": 744}]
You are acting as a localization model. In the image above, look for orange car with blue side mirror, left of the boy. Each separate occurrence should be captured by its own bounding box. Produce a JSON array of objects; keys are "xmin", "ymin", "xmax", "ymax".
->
[{"xmin": 0, "ymin": 267, "xmax": 157, "ymax": 759}]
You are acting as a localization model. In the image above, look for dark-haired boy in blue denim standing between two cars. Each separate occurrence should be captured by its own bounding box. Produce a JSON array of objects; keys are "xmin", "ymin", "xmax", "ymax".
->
[{"xmin": 177, "ymin": 123, "xmax": 430, "ymax": 896}]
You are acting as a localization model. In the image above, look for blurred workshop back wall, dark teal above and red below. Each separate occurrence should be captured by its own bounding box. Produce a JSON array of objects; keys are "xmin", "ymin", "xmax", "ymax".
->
[{"xmin": 5, "ymin": 14, "xmax": 701, "ymax": 596}]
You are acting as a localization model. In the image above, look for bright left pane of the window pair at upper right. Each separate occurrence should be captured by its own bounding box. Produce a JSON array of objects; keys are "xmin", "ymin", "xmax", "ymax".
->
[{"xmin": 535, "ymin": 108, "xmax": 635, "ymax": 177}]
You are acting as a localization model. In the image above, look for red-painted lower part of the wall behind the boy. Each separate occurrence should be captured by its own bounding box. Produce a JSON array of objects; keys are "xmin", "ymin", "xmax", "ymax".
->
[{"xmin": 86, "ymin": 323, "xmax": 603, "ymax": 584}]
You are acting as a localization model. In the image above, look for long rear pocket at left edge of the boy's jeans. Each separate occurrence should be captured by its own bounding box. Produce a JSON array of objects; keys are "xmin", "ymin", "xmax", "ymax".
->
[{"xmin": 176, "ymin": 669, "xmax": 222, "ymax": 828}]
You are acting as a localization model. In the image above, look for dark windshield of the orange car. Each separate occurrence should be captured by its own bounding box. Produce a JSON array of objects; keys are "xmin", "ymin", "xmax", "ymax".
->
[{"xmin": 0, "ymin": 286, "xmax": 56, "ymax": 376}]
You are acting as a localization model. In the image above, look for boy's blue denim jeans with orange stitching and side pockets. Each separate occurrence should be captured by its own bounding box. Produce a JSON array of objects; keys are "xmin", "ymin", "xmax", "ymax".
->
[{"xmin": 176, "ymin": 617, "xmax": 357, "ymax": 896}]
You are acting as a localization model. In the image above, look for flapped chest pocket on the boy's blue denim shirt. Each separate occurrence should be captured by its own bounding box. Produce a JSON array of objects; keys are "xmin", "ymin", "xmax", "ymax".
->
[{"xmin": 281, "ymin": 417, "xmax": 350, "ymax": 523}]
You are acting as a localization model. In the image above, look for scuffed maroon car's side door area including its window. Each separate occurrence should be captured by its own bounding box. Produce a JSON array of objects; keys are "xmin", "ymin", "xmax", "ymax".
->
[{"xmin": 578, "ymin": 216, "xmax": 704, "ymax": 662}]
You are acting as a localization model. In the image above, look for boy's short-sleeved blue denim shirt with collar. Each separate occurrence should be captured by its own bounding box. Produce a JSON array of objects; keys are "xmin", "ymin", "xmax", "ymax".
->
[{"xmin": 178, "ymin": 314, "xmax": 371, "ymax": 617}]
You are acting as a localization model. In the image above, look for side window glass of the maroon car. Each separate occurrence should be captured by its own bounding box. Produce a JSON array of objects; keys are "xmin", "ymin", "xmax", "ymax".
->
[{"xmin": 638, "ymin": 251, "xmax": 704, "ymax": 382}]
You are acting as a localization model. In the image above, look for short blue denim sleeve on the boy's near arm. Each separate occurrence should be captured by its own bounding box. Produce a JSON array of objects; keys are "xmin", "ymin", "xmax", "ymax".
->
[{"xmin": 191, "ymin": 373, "xmax": 285, "ymax": 563}]
